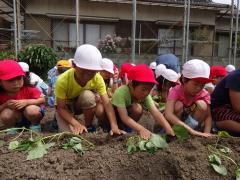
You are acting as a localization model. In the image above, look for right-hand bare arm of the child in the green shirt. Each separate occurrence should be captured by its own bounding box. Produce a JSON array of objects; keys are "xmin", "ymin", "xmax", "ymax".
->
[{"xmin": 149, "ymin": 105, "xmax": 175, "ymax": 136}]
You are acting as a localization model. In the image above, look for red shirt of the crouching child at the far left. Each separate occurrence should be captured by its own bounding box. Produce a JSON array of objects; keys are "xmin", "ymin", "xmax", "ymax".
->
[{"xmin": 0, "ymin": 86, "xmax": 41, "ymax": 104}]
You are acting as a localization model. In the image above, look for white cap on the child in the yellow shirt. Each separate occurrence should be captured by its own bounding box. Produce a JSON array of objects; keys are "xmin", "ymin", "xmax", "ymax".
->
[{"xmin": 73, "ymin": 44, "xmax": 102, "ymax": 70}]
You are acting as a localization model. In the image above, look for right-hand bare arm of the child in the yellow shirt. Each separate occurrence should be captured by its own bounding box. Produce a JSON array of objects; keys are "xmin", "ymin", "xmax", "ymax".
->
[{"xmin": 100, "ymin": 94, "xmax": 125, "ymax": 134}]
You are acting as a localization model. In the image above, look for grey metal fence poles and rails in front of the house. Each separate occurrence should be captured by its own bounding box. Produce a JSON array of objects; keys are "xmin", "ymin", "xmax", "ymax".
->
[{"xmin": 0, "ymin": 0, "xmax": 239, "ymax": 65}]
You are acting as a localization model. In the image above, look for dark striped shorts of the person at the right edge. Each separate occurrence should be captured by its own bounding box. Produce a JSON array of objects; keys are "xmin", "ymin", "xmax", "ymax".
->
[{"xmin": 212, "ymin": 105, "xmax": 240, "ymax": 122}]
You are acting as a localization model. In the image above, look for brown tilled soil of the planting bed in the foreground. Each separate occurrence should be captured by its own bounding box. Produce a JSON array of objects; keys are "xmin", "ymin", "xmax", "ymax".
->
[{"xmin": 0, "ymin": 109, "xmax": 240, "ymax": 180}]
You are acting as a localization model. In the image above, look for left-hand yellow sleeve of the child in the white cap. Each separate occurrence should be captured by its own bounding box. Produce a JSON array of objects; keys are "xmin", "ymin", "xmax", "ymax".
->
[{"xmin": 54, "ymin": 76, "xmax": 68, "ymax": 99}]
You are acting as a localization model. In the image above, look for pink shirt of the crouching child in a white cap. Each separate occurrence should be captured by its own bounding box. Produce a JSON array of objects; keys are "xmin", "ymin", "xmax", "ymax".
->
[{"xmin": 168, "ymin": 85, "xmax": 211, "ymax": 107}]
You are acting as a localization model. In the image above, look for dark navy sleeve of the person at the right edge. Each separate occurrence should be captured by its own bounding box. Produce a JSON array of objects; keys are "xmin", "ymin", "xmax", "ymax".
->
[{"xmin": 225, "ymin": 71, "xmax": 240, "ymax": 92}]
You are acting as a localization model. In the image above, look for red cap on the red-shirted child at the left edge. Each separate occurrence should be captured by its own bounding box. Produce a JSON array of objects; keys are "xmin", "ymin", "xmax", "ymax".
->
[{"xmin": 0, "ymin": 60, "xmax": 25, "ymax": 80}]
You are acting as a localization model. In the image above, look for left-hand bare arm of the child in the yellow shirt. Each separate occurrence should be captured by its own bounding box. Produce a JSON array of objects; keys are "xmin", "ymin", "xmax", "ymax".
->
[{"xmin": 56, "ymin": 98, "xmax": 87, "ymax": 134}]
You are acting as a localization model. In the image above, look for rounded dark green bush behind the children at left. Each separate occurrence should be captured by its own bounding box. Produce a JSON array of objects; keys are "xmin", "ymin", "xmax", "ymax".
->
[{"xmin": 18, "ymin": 44, "xmax": 58, "ymax": 79}]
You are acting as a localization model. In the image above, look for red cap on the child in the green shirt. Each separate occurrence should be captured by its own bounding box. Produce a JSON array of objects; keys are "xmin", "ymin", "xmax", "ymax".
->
[{"xmin": 128, "ymin": 64, "xmax": 158, "ymax": 84}]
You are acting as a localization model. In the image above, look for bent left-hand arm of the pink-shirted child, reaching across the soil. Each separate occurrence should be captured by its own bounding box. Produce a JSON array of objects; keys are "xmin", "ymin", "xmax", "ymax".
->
[{"xmin": 165, "ymin": 100, "xmax": 210, "ymax": 137}]
